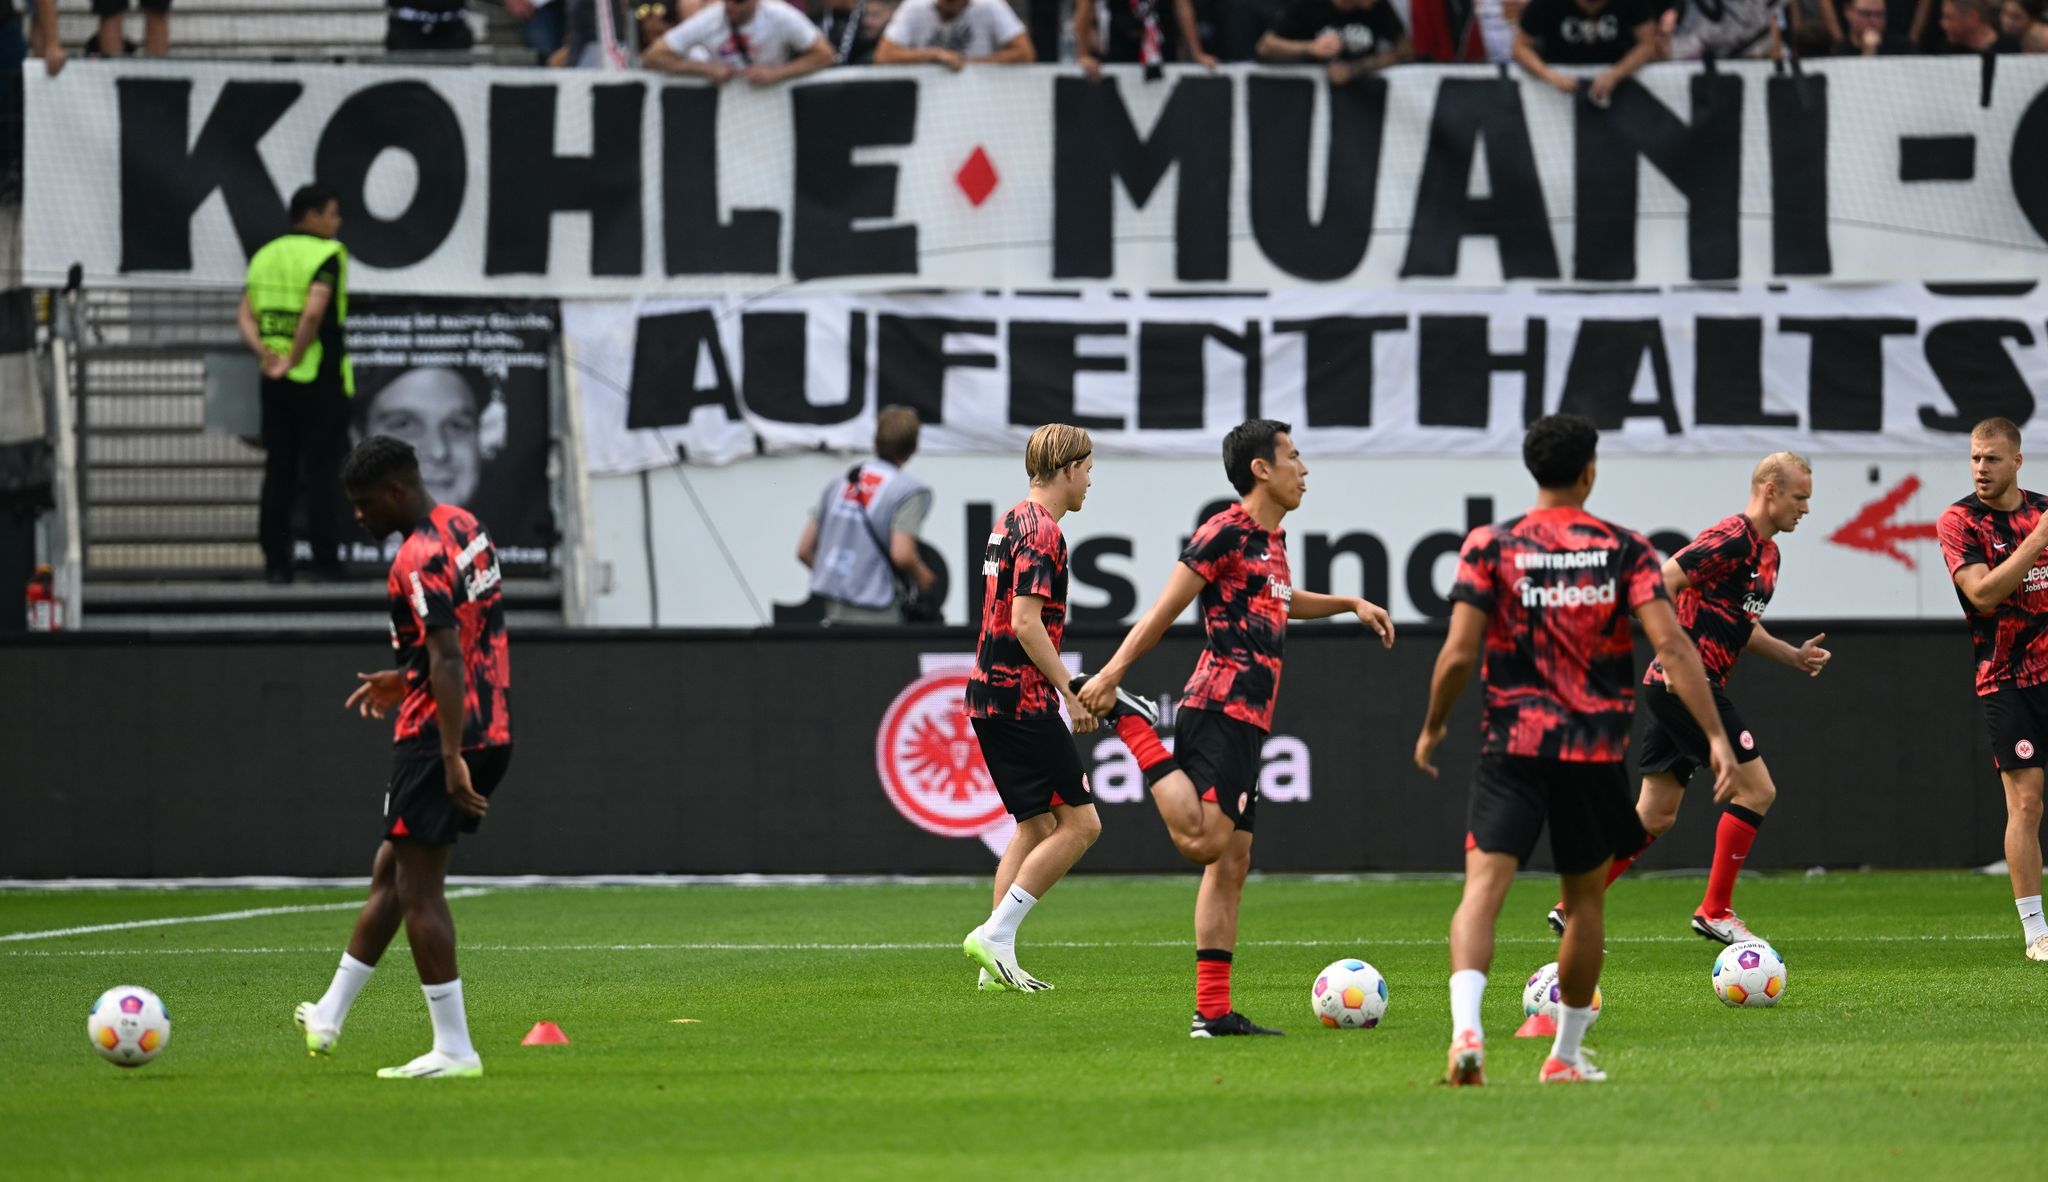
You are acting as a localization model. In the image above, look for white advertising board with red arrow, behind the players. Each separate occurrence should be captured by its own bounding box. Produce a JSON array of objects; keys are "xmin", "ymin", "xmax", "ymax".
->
[{"xmin": 590, "ymin": 442, "xmax": 1972, "ymax": 626}]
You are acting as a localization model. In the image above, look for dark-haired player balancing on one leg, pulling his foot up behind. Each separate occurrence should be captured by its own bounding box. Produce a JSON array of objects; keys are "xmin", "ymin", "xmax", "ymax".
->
[{"xmin": 1081, "ymin": 418, "xmax": 1395, "ymax": 1039}]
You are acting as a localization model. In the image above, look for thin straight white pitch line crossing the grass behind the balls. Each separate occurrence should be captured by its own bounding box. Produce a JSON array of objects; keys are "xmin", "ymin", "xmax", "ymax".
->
[{"xmin": 0, "ymin": 930, "xmax": 2011, "ymax": 957}]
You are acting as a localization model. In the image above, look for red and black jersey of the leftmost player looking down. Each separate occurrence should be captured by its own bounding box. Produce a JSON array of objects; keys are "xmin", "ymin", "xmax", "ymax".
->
[{"xmin": 389, "ymin": 504, "xmax": 512, "ymax": 752}]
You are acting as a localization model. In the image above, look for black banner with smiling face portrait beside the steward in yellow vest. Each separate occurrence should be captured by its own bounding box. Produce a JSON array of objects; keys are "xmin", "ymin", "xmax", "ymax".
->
[{"xmin": 342, "ymin": 299, "xmax": 557, "ymax": 574}]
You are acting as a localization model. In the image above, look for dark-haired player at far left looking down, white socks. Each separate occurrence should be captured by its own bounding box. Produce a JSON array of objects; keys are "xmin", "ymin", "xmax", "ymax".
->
[{"xmin": 293, "ymin": 434, "xmax": 512, "ymax": 1080}]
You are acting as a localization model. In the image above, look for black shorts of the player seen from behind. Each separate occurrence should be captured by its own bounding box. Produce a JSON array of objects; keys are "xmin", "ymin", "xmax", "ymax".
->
[{"xmin": 1464, "ymin": 756, "xmax": 1642, "ymax": 875}]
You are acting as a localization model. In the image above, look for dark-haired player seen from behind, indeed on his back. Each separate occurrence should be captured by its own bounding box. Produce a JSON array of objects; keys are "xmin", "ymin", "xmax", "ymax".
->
[{"xmin": 1415, "ymin": 414, "xmax": 1735, "ymax": 1086}]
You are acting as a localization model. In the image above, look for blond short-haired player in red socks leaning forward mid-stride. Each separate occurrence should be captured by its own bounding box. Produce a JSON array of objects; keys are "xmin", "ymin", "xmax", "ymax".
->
[{"xmin": 1550, "ymin": 451, "xmax": 1831, "ymax": 944}]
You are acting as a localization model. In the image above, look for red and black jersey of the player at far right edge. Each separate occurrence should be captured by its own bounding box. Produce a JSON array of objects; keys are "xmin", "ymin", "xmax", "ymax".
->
[{"xmin": 1933, "ymin": 490, "xmax": 2048, "ymax": 694}]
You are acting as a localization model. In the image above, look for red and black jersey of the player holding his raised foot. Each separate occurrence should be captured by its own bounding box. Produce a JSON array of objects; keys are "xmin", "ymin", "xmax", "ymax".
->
[{"xmin": 1180, "ymin": 504, "xmax": 1294, "ymax": 731}]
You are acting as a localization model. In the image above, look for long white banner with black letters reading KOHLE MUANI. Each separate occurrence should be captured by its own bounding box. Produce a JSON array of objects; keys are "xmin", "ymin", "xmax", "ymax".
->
[{"xmin": 25, "ymin": 55, "xmax": 2048, "ymax": 297}]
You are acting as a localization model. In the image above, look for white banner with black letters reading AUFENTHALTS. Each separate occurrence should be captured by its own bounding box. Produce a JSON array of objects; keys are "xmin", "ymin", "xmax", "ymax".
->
[{"xmin": 563, "ymin": 285, "xmax": 2048, "ymax": 473}]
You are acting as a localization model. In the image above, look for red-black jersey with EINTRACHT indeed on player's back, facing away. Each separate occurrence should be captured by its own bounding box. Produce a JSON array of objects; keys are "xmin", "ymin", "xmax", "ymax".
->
[{"xmin": 1450, "ymin": 508, "xmax": 1667, "ymax": 764}]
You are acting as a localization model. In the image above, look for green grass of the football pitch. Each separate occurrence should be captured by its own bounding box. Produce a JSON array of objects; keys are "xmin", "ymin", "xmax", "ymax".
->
[{"xmin": 0, "ymin": 875, "xmax": 2048, "ymax": 1182}]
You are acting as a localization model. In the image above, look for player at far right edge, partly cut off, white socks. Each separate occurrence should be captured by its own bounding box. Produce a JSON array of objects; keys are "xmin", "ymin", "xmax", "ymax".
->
[{"xmin": 1935, "ymin": 418, "xmax": 2048, "ymax": 961}]
